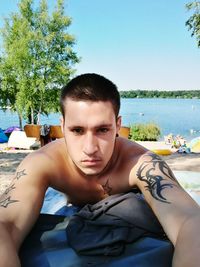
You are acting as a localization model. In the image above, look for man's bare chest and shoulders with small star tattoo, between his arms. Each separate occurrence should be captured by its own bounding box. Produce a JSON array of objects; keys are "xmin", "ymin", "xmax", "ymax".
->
[{"xmin": 36, "ymin": 138, "xmax": 146, "ymax": 205}]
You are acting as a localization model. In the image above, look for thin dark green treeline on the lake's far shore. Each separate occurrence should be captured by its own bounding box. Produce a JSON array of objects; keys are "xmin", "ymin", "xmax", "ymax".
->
[{"xmin": 120, "ymin": 90, "xmax": 200, "ymax": 99}]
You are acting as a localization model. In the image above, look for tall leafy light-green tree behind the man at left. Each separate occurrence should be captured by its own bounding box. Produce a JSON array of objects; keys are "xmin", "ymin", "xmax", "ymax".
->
[{"xmin": 0, "ymin": 0, "xmax": 79, "ymax": 127}]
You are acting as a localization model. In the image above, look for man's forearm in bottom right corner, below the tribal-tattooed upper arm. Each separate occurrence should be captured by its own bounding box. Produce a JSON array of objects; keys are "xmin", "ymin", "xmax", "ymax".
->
[{"xmin": 172, "ymin": 215, "xmax": 200, "ymax": 267}]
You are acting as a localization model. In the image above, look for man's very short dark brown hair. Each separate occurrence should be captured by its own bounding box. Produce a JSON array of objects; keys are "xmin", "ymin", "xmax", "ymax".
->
[{"xmin": 60, "ymin": 73, "xmax": 120, "ymax": 118}]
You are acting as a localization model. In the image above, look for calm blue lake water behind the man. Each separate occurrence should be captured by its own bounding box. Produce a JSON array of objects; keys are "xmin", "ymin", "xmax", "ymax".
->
[{"xmin": 0, "ymin": 98, "xmax": 200, "ymax": 140}]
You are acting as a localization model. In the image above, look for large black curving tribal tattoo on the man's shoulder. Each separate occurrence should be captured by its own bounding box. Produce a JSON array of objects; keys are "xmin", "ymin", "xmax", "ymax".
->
[{"xmin": 137, "ymin": 153, "xmax": 178, "ymax": 203}]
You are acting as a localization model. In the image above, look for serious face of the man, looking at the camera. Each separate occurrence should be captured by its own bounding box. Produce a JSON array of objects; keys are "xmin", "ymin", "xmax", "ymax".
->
[{"xmin": 62, "ymin": 98, "xmax": 121, "ymax": 175}]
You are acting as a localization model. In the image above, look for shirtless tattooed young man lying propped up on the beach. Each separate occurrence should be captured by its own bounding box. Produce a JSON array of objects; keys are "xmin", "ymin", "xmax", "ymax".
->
[{"xmin": 0, "ymin": 74, "xmax": 200, "ymax": 267}]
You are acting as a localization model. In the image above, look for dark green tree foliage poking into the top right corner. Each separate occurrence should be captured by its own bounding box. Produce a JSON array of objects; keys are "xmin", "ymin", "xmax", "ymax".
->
[{"xmin": 185, "ymin": 1, "xmax": 200, "ymax": 47}]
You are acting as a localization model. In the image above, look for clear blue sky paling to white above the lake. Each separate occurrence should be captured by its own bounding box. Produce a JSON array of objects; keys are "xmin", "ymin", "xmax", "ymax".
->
[{"xmin": 0, "ymin": 0, "xmax": 200, "ymax": 90}]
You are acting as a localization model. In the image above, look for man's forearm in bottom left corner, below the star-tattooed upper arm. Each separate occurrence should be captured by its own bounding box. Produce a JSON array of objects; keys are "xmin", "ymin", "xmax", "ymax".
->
[{"xmin": 0, "ymin": 223, "xmax": 21, "ymax": 267}]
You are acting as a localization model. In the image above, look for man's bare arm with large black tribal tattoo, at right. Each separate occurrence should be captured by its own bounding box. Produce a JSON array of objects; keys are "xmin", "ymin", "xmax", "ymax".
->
[{"xmin": 131, "ymin": 152, "xmax": 200, "ymax": 267}]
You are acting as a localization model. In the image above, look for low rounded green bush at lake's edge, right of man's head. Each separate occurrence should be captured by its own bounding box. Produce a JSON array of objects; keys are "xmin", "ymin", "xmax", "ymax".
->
[{"xmin": 130, "ymin": 123, "xmax": 161, "ymax": 141}]
